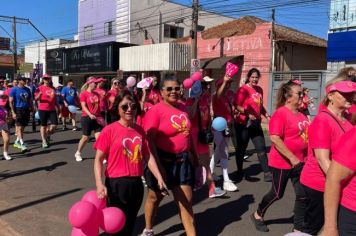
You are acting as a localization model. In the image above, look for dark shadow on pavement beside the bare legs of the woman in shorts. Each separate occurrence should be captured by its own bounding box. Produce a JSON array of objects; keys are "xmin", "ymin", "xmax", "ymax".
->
[{"xmin": 155, "ymin": 194, "xmax": 255, "ymax": 236}]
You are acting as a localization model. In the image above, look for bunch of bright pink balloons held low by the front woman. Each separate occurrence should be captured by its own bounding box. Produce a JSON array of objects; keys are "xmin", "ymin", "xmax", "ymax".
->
[{"xmin": 68, "ymin": 190, "xmax": 126, "ymax": 236}]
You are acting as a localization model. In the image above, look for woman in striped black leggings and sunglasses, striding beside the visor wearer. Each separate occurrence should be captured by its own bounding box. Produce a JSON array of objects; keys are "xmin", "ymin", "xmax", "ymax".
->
[{"xmin": 251, "ymin": 81, "xmax": 309, "ymax": 232}]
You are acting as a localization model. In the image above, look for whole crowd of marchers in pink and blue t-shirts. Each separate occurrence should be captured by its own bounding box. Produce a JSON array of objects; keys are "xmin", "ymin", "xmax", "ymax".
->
[{"xmin": 0, "ymin": 68, "xmax": 356, "ymax": 236}]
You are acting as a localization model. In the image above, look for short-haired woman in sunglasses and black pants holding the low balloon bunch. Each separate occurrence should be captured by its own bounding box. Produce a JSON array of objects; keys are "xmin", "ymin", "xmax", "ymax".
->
[{"xmin": 94, "ymin": 90, "xmax": 166, "ymax": 236}]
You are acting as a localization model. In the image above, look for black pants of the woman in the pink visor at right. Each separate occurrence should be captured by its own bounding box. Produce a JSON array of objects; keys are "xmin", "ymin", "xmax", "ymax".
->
[{"xmin": 303, "ymin": 185, "xmax": 324, "ymax": 235}]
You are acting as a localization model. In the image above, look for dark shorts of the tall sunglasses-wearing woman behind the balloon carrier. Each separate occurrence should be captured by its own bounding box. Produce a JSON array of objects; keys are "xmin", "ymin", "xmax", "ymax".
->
[{"xmin": 144, "ymin": 149, "xmax": 195, "ymax": 192}]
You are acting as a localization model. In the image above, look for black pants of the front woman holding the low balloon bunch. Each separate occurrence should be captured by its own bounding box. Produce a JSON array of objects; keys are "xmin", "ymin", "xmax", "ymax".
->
[{"xmin": 105, "ymin": 177, "xmax": 143, "ymax": 236}]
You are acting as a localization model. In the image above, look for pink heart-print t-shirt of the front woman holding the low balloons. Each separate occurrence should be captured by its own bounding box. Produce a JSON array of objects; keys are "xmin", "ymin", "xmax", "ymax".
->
[{"xmin": 94, "ymin": 122, "xmax": 149, "ymax": 178}]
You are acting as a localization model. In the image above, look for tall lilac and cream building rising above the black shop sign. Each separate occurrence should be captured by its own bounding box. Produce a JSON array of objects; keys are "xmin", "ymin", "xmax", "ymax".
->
[{"xmin": 78, "ymin": 0, "xmax": 233, "ymax": 46}]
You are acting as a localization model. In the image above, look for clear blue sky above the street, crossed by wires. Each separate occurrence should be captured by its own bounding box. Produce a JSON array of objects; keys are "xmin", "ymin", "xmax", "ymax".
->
[{"xmin": 0, "ymin": 0, "xmax": 330, "ymax": 48}]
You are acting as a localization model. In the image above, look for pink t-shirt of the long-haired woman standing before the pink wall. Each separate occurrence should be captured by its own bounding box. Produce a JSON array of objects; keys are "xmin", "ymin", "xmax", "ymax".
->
[{"xmin": 234, "ymin": 84, "xmax": 263, "ymax": 124}]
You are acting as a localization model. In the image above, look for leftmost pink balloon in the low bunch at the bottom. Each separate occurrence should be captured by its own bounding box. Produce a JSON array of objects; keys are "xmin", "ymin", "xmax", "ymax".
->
[{"xmin": 68, "ymin": 201, "xmax": 97, "ymax": 228}]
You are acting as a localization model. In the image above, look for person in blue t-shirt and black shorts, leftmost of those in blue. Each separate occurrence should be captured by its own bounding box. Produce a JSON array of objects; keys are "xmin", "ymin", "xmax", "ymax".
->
[{"xmin": 9, "ymin": 77, "xmax": 33, "ymax": 152}]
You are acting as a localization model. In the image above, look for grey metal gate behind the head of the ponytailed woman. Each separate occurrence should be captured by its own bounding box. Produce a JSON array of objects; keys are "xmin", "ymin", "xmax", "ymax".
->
[{"xmin": 268, "ymin": 71, "xmax": 326, "ymax": 117}]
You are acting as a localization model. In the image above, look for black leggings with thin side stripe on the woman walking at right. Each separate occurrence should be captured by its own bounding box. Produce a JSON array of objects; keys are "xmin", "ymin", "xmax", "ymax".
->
[{"xmin": 257, "ymin": 165, "xmax": 307, "ymax": 231}]
